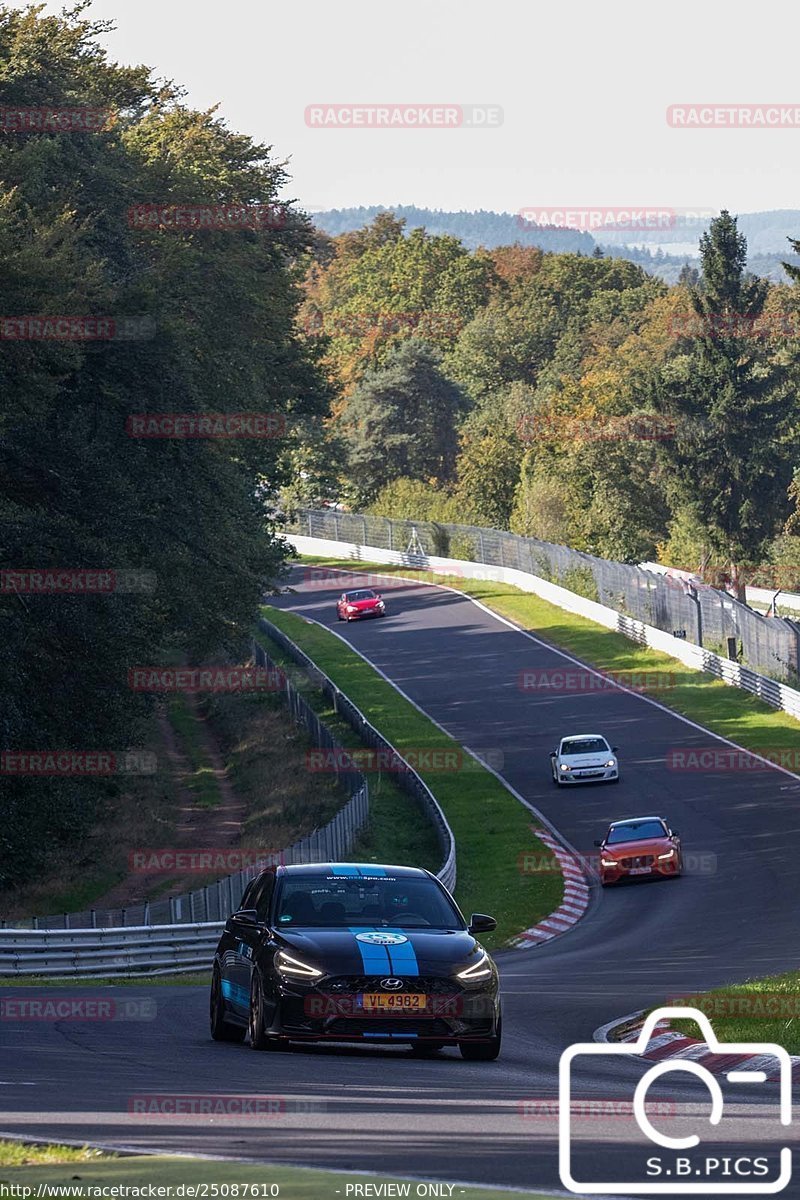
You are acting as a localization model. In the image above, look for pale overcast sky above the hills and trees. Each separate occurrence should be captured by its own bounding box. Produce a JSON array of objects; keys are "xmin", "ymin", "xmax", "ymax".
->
[{"xmin": 28, "ymin": 0, "xmax": 800, "ymax": 212}]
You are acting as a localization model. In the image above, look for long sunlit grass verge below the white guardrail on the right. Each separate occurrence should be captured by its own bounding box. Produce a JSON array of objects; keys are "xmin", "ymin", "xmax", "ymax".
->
[{"xmin": 302, "ymin": 557, "xmax": 800, "ymax": 762}]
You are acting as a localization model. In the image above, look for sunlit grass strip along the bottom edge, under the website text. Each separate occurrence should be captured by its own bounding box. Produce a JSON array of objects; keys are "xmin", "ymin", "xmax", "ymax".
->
[{"xmin": 0, "ymin": 1142, "xmax": 563, "ymax": 1200}]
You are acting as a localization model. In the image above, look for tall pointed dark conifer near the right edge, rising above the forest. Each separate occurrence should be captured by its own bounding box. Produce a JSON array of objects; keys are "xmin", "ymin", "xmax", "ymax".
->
[{"xmin": 652, "ymin": 211, "xmax": 794, "ymax": 598}]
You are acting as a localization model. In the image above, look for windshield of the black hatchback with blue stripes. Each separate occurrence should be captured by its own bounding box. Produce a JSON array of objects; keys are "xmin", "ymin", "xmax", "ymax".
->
[{"xmin": 275, "ymin": 874, "xmax": 465, "ymax": 929}]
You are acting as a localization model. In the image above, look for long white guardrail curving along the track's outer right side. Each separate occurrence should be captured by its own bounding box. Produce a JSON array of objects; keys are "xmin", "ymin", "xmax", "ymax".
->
[{"xmin": 284, "ymin": 534, "xmax": 800, "ymax": 720}]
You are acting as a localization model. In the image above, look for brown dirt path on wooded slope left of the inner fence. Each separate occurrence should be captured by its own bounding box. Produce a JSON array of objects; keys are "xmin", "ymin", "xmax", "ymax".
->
[{"xmin": 92, "ymin": 696, "xmax": 245, "ymax": 910}]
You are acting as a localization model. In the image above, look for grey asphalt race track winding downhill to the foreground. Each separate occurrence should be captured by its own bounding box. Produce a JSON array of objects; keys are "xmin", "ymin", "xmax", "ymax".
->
[{"xmin": 0, "ymin": 568, "xmax": 800, "ymax": 1196}]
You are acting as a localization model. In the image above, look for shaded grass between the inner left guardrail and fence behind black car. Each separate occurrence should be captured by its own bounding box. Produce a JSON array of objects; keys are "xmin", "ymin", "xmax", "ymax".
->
[{"xmin": 255, "ymin": 630, "xmax": 441, "ymax": 871}]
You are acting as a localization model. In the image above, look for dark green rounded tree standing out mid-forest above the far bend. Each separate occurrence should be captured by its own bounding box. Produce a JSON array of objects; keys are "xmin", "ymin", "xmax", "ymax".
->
[{"xmin": 341, "ymin": 338, "xmax": 465, "ymax": 504}]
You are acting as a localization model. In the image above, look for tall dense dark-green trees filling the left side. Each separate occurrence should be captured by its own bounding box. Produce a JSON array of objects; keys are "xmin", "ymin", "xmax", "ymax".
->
[{"xmin": 0, "ymin": 5, "xmax": 327, "ymax": 886}]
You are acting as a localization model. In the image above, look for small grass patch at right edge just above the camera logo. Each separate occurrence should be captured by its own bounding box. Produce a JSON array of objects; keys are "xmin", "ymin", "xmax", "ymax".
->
[{"xmin": 652, "ymin": 971, "xmax": 800, "ymax": 1055}]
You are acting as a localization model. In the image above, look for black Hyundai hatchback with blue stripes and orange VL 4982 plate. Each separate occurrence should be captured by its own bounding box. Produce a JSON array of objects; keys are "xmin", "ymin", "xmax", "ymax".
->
[{"xmin": 211, "ymin": 863, "xmax": 501, "ymax": 1062}]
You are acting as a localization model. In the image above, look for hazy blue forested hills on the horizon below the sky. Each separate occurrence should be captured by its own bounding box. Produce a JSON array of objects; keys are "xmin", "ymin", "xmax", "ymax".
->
[{"xmin": 312, "ymin": 204, "xmax": 800, "ymax": 283}]
